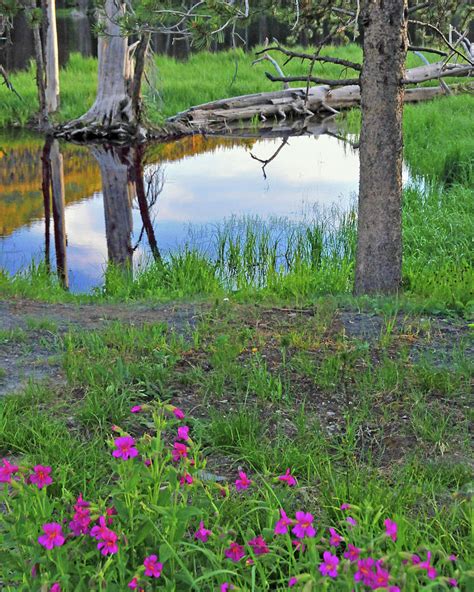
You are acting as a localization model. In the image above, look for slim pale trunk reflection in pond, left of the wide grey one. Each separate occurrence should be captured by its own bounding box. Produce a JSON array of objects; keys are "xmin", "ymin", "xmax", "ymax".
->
[{"xmin": 50, "ymin": 140, "xmax": 69, "ymax": 289}]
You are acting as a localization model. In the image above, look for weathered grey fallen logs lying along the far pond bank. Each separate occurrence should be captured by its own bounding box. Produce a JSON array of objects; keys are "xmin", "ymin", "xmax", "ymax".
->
[{"xmin": 168, "ymin": 56, "xmax": 474, "ymax": 132}]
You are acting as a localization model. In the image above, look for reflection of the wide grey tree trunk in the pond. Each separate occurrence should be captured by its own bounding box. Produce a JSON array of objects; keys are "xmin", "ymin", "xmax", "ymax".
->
[{"xmin": 92, "ymin": 146, "xmax": 133, "ymax": 274}]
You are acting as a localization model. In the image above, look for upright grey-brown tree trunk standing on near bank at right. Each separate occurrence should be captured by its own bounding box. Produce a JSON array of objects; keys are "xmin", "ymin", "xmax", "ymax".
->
[{"xmin": 354, "ymin": 0, "xmax": 407, "ymax": 294}]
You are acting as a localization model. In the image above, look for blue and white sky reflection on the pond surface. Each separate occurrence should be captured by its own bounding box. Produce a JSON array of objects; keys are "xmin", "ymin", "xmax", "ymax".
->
[{"xmin": 0, "ymin": 136, "xmax": 359, "ymax": 291}]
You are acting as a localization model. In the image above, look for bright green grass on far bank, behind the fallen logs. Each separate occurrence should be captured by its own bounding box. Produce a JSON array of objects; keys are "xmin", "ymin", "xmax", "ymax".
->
[{"xmin": 0, "ymin": 45, "xmax": 452, "ymax": 127}]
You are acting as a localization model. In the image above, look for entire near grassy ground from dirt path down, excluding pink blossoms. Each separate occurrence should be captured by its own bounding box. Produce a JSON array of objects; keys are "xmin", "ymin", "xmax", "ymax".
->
[{"xmin": 0, "ymin": 299, "xmax": 473, "ymax": 592}]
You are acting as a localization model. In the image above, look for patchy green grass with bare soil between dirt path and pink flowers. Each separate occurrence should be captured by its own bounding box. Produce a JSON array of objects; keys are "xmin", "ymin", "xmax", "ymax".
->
[{"xmin": 0, "ymin": 299, "xmax": 473, "ymax": 590}]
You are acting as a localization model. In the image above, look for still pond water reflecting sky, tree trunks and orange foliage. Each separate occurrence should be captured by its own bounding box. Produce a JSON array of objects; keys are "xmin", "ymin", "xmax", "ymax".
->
[{"xmin": 0, "ymin": 135, "xmax": 359, "ymax": 292}]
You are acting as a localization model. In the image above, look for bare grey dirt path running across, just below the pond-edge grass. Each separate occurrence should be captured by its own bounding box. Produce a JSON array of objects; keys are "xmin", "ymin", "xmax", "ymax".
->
[{"xmin": 0, "ymin": 299, "xmax": 474, "ymax": 396}]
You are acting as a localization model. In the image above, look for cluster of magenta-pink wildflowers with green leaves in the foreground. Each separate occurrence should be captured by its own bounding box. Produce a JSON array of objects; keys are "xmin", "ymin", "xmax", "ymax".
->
[{"xmin": 0, "ymin": 403, "xmax": 462, "ymax": 592}]
